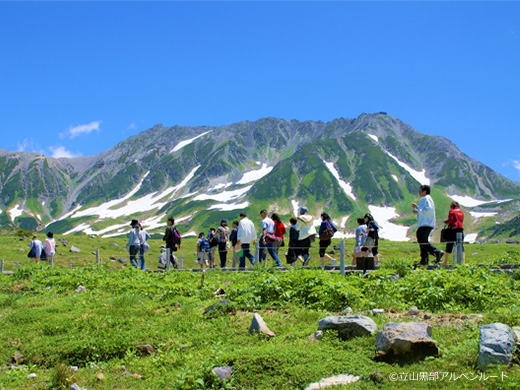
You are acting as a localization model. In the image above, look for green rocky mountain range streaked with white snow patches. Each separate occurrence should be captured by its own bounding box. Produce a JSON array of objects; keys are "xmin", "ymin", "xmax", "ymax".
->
[{"xmin": 0, "ymin": 112, "xmax": 520, "ymax": 241}]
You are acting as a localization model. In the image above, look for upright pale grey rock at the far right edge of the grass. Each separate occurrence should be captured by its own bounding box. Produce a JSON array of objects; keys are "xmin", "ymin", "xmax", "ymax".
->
[{"xmin": 477, "ymin": 322, "xmax": 515, "ymax": 371}]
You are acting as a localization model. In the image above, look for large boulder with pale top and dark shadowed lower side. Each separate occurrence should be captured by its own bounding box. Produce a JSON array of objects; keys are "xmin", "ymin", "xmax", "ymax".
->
[{"xmin": 376, "ymin": 322, "xmax": 439, "ymax": 363}]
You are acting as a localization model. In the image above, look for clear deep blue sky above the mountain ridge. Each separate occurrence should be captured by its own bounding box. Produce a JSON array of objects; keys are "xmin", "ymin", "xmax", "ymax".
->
[{"xmin": 0, "ymin": 1, "xmax": 520, "ymax": 181}]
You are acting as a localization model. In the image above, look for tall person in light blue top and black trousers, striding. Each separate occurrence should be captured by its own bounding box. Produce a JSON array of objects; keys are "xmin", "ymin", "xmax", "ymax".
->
[{"xmin": 412, "ymin": 184, "xmax": 444, "ymax": 265}]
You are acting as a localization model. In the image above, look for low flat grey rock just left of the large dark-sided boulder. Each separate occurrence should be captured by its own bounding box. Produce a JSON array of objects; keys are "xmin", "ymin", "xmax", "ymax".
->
[{"xmin": 319, "ymin": 315, "xmax": 377, "ymax": 340}]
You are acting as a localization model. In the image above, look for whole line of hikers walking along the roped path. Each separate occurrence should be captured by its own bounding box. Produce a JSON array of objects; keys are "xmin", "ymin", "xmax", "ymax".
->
[{"xmin": 24, "ymin": 185, "xmax": 464, "ymax": 270}]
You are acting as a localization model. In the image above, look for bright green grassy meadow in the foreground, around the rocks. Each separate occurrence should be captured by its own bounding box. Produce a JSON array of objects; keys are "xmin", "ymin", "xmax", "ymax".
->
[{"xmin": 0, "ymin": 230, "xmax": 520, "ymax": 389}]
